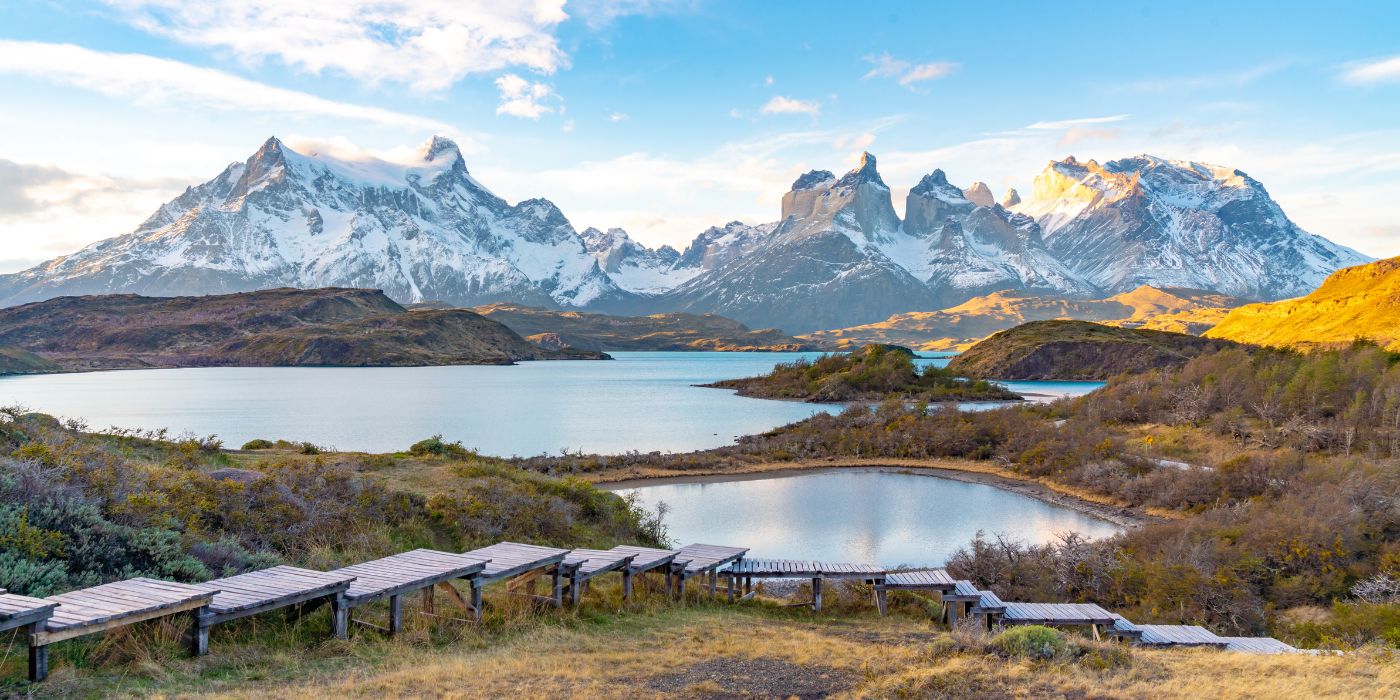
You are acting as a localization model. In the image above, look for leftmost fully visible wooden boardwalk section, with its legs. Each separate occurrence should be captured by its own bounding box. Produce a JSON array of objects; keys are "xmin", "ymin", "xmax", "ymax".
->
[{"xmin": 29, "ymin": 578, "xmax": 214, "ymax": 680}]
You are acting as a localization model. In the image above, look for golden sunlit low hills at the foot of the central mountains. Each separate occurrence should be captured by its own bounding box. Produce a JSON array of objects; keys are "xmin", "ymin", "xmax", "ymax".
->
[{"xmin": 801, "ymin": 284, "xmax": 1245, "ymax": 350}]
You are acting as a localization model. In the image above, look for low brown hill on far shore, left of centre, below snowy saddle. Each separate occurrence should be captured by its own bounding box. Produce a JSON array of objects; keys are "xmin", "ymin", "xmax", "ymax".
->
[{"xmin": 472, "ymin": 304, "xmax": 822, "ymax": 351}]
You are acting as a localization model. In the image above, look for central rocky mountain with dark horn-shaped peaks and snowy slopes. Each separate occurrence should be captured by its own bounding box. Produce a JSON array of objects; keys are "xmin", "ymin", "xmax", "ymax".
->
[{"xmin": 666, "ymin": 153, "xmax": 1098, "ymax": 332}]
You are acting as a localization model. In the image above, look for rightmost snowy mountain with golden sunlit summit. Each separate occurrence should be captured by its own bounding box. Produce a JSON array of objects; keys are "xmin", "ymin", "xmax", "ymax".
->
[{"xmin": 1012, "ymin": 155, "xmax": 1371, "ymax": 300}]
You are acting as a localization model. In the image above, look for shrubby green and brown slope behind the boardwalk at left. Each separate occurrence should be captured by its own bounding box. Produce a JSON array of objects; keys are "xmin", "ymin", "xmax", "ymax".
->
[{"xmin": 0, "ymin": 409, "xmax": 661, "ymax": 596}]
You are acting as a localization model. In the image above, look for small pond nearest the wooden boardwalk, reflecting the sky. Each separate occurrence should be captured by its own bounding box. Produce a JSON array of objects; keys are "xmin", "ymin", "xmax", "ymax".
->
[{"xmin": 617, "ymin": 469, "xmax": 1119, "ymax": 567}]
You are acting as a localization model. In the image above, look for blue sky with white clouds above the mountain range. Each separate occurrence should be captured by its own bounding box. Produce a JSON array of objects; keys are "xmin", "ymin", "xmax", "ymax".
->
[{"xmin": 0, "ymin": 0, "xmax": 1400, "ymax": 273}]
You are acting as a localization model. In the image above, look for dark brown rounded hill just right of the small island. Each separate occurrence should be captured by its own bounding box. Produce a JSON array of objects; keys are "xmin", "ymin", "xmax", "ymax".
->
[{"xmin": 948, "ymin": 321, "xmax": 1235, "ymax": 379}]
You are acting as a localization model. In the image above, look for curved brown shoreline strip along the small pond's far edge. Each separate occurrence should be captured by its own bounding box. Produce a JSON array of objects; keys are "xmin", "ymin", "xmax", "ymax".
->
[{"xmin": 589, "ymin": 459, "xmax": 1165, "ymax": 529}]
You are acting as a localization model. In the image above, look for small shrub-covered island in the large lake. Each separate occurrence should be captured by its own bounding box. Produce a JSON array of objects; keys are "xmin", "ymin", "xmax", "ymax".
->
[{"xmin": 703, "ymin": 344, "xmax": 1021, "ymax": 403}]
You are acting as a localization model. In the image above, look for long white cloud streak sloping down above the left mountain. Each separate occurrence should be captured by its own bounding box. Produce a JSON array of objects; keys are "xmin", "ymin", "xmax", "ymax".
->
[{"xmin": 0, "ymin": 39, "xmax": 454, "ymax": 133}]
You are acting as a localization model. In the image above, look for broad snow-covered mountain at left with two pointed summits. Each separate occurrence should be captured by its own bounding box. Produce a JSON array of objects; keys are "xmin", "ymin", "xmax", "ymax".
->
[{"xmin": 0, "ymin": 137, "xmax": 629, "ymax": 307}]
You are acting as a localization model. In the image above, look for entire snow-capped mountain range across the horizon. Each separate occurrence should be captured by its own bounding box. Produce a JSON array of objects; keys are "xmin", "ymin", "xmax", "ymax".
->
[{"xmin": 0, "ymin": 137, "xmax": 1369, "ymax": 333}]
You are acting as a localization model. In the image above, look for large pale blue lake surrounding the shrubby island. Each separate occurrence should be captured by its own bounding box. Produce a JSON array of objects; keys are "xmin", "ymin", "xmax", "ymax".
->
[{"xmin": 0, "ymin": 353, "xmax": 1099, "ymax": 455}]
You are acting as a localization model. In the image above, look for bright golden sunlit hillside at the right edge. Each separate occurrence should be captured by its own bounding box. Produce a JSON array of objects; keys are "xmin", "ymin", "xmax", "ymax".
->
[{"xmin": 1205, "ymin": 258, "xmax": 1400, "ymax": 351}]
